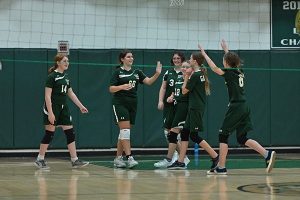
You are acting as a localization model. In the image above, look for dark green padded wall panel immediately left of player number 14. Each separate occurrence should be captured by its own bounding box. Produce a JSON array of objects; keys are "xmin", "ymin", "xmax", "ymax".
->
[{"xmin": 14, "ymin": 49, "xmax": 47, "ymax": 148}]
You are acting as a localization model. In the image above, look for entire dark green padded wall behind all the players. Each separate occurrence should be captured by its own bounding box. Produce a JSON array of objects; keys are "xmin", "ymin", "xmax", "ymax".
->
[{"xmin": 0, "ymin": 49, "xmax": 300, "ymax": 149}]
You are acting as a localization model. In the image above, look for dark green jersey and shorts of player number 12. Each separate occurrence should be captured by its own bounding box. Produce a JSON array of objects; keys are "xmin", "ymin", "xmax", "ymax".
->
[{"xmin": 171, "ymin": 71, "xmax": 189, "ymax": 128}]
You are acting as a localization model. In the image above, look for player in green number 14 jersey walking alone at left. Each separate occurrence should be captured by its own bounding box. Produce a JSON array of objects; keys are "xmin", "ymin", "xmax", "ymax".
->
[{"xmin": 35, "ymin": 54, "xmax": 89, "ymax": 169}]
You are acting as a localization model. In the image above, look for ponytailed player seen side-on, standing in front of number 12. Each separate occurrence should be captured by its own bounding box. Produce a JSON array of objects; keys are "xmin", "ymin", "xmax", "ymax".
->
[{"xmin": 168, "ymin": 53, "xmax": 218, "ymax": 169}]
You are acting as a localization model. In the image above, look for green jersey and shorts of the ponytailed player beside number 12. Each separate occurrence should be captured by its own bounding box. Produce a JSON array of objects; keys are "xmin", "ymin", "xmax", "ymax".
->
[{"xmin": 184, "ymin": 70, "xmax": 206, "ymax": 132}]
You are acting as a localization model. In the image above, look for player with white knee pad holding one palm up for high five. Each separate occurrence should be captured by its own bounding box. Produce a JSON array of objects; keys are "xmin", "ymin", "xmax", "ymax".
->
[{"xmin": 109, "ymin": 50, "xmax": 162, "ymax": 168}]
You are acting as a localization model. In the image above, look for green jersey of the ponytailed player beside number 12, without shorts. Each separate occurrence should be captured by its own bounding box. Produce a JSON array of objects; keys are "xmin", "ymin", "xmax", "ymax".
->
[{"xmin": 186, "ymin": 70, "xmax": 206, "ymax": 110}]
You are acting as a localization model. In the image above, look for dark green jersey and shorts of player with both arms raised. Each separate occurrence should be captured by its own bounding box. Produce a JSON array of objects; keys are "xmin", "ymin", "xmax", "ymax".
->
[{"xmin": 220, "ymin": 70, "xmax": 253, "ymax": 136}]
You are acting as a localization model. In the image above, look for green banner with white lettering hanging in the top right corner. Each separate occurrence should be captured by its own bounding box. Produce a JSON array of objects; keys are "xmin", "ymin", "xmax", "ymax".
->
[{"xmin": 271, "ymin": 0, "xmax": 300, "ymax": 48}]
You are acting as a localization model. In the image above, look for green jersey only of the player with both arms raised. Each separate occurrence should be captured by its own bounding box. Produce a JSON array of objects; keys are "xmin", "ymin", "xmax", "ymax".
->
[{"xmin": 223, "ymin": 69, "xmax": 246, "ymax": 103}]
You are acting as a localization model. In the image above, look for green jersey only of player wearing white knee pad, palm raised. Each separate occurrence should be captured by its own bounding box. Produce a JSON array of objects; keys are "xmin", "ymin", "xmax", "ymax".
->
[{"xmin": 110, "ymin": 67, "xmax": 147, "ymax": 98}]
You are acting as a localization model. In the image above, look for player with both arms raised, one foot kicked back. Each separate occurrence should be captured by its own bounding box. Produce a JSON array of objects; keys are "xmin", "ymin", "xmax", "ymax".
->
[{"xmin": 199, "ymin": 40, "xmax": 276, "ymax": 175}]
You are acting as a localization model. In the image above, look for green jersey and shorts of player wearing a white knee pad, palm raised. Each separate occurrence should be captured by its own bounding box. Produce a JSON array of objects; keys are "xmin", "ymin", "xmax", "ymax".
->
[{"xmin": 110, "ymin": 67, "xmax": 146, "ymax": 125}]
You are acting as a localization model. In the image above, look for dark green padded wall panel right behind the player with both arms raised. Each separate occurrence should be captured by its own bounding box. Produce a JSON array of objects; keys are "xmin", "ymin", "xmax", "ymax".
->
[{"xmin": 239, "ymin": 51, "xmax": 275, "ymax": 145}]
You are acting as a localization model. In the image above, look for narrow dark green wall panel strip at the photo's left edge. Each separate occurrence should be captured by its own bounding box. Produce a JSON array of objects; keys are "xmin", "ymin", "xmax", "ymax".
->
[{"xmin": 0, "ymin": 49, "xmax": 14, "ymax": 148}]
